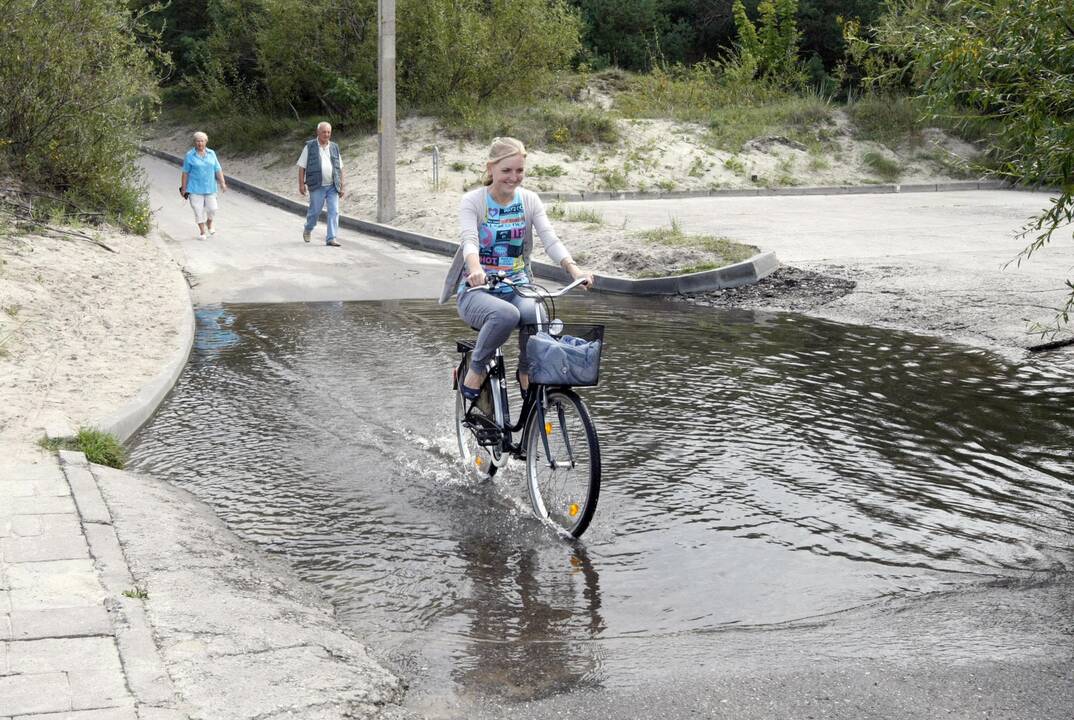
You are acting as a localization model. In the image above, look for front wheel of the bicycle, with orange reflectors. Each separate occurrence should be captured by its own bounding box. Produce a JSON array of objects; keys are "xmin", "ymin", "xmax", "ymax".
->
[{"xmin": 526, "ymin": 390, "xmax": 600, "ymax": 537}]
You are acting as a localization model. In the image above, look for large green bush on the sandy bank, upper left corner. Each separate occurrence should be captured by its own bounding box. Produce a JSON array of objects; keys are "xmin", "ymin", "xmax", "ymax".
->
[{"xmin": 0, "ymin": 0, "xmax": 157, "ymax": 230}]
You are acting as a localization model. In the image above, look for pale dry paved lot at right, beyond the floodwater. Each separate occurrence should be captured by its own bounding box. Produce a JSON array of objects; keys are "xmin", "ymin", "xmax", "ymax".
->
[{"xmin": 580, "ymin": 190, "xmax": 1074, "ymax": 355}]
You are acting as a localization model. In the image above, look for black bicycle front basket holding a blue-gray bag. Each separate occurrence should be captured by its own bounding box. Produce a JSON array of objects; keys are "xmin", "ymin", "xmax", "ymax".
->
[{"xmin": 523, "ymin": 322, "xmax": 605, "ymax": 387}]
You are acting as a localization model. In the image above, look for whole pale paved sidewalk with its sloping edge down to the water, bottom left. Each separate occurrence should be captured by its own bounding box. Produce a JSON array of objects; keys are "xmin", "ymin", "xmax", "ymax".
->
[{"xmin": 0, "ymin": 445, "xmax": 413, "ymax": 720}]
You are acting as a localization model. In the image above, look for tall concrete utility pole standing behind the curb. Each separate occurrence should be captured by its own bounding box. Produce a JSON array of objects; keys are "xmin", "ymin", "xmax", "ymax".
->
[{"xmin": 377, "ymin": 0, "xmax": 395, "ymax": 222}]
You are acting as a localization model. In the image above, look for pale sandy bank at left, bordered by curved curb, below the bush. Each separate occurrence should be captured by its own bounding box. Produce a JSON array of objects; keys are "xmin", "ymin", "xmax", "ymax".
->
[{"xmin": 0, "ymin": 229, "xmax": 189, "ymax": 459}]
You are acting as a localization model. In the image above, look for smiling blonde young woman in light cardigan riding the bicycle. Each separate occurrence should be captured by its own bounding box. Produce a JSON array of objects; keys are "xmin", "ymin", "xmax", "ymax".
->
[{"xmin": 440, "ymin": 138, "xmax": 593, "ymax": 400}]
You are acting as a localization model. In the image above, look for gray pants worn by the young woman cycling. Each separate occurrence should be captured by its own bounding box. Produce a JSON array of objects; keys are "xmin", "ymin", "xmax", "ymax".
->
[{"xmin": 459, "ymin": 290, "xmax": 545, "ymax": 373}]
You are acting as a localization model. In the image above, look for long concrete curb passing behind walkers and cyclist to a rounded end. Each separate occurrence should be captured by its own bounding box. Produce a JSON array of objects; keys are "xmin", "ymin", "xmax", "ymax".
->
[{"xmin": 142, "ymin": 145, "xmax": 780, "ymax": 296}]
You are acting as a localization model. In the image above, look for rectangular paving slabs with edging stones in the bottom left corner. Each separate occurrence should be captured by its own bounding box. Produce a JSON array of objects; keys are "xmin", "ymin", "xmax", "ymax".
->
[{"xmin": 0, "ymin": 452, "xmax": 187, "ymax": 720}]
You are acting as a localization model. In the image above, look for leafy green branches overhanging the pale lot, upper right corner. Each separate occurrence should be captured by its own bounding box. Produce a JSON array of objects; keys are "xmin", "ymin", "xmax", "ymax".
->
[{"xmin": 859, "ymin": 0, "xmax": 1074, "ymax": 333}]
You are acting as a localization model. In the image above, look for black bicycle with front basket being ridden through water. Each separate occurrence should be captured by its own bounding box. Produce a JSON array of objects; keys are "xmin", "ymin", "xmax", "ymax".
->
[{"xmin": 452, "ymin": 276, "xmax": 604, "ymax": 537}]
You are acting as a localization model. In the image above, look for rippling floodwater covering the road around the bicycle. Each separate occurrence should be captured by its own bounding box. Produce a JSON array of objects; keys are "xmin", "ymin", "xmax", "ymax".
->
[{"xmin": 131, "ymin": 299, "xmax": 1074, "ymax": 718}]
